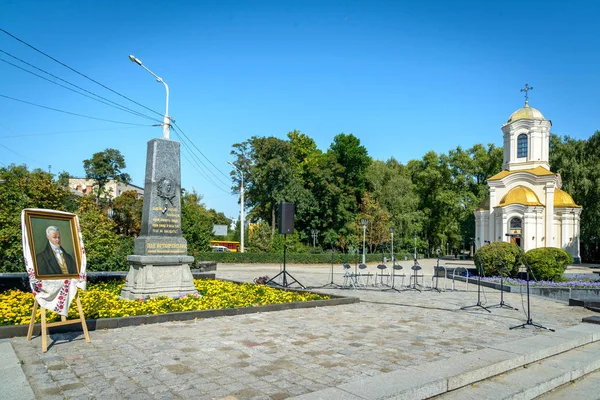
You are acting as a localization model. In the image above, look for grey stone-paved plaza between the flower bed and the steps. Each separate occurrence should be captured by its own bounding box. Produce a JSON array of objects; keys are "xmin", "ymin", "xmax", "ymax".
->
[{"xmin": 0, "ymin": 260, "xmax": 590, "ymax": 400}]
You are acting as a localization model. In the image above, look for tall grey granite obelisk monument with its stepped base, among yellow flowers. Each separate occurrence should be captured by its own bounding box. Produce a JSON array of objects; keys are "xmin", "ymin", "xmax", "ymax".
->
[{"xmin": 121, "ymin": 138, "xmax": 197, "ymax": 299}]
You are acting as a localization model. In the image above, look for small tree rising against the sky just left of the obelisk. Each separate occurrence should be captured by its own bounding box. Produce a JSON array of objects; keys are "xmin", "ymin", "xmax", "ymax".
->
[{"xmin": 83, "ymin": 149, "xmax": 131, "ymax": 204}]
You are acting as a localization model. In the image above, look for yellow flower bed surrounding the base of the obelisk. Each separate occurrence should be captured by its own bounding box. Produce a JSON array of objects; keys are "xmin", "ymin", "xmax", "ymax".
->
[{"xmin": 0, "ymin": 279, "xmax": 329, "ymax": 325}]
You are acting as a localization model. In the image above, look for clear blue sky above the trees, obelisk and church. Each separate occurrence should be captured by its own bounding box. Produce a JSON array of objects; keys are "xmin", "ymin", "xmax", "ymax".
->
[{"xmin": 0, "ymin": 0, "xmax": 600, "ymax": 218}]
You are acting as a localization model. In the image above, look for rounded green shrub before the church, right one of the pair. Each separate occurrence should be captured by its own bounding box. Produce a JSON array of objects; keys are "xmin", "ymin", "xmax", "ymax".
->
[{"xmin": 525, "ymin": 247, "xmax": 573, "ymax": 281}]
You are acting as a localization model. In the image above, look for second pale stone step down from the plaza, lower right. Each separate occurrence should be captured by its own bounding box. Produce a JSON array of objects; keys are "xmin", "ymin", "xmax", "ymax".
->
[{"xmin": 435, "ymin": 342, "xmax": 600, "ymax": 400}]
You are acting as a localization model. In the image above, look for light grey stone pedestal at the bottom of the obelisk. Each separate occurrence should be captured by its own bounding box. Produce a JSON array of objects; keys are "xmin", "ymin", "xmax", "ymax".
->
[{"xmin": 121, "ymin": 255, "xmax": 197, "ymax": 300}]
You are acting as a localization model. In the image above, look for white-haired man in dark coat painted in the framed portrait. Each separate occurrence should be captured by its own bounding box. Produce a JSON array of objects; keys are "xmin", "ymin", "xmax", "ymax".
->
[{"xmin": 35, "ymin": 225, "xmax": 77, "ymax": 275}]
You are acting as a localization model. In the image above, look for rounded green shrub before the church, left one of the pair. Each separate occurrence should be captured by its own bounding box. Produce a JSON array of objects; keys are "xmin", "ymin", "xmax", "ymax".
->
[{"xmin": 474, "ymin": 242, "xmax": 523, "ymax": 276}]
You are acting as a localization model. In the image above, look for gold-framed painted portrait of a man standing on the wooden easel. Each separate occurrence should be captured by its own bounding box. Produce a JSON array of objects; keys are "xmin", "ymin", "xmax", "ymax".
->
[{"xmin": 24, "ymin": 210, "xmax": 81, "ymax": 280}]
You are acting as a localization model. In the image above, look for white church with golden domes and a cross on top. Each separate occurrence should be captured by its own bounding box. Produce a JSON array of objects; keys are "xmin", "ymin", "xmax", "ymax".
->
[{"xmin": 475, "ymin": 85, "xmax": 582, "ymax": 263}]
